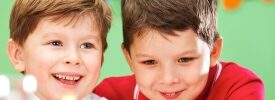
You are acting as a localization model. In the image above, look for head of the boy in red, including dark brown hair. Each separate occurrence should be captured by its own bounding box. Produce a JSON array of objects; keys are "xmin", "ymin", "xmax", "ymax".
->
[{"xmin": 122, "ymin": 0, "xmax": 222, "ymax": 100}]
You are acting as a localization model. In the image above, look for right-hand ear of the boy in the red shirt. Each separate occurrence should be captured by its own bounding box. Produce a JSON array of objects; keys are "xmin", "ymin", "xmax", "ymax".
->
[{"xmin": 210, "ymin": 37, "xmax": 223, "ymax": 67}]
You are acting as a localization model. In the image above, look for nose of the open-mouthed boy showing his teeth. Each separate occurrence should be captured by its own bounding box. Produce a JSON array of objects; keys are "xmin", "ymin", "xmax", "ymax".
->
[{"xmin": 63, "ymin": 49, "xmax": 80, "ymax": 65}]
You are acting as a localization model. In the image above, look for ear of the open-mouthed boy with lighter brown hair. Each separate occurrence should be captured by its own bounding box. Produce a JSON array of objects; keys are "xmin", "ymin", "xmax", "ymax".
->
[{"xmin": 7, "ymin": 39, "xmax": 25, "ymax": 72}]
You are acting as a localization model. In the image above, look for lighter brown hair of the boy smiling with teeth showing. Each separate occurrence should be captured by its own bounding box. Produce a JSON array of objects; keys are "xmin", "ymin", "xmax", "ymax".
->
[{"xmin": 10, "ymin": 0, "xmax": 111, "ymax": 50}]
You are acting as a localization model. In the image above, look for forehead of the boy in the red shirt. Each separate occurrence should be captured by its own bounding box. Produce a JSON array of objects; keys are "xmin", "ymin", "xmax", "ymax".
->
[{"xmin": 130, "ymin": 29, "xmax": 210, "ymax": 54}]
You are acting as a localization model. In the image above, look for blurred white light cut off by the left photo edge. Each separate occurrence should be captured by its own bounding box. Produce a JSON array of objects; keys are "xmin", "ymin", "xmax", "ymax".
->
[{"xmin": 0, "ymin": 75, "xmax": 10, "ymax": 97}]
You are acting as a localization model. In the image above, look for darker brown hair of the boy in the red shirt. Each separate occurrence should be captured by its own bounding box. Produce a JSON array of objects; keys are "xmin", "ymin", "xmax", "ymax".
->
[{"xmin": 121, "ymin": 0, "xmax": 219, "ymax": 52}]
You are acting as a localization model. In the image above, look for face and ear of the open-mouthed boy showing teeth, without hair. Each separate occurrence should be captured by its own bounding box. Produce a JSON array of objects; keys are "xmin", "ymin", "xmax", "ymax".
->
[{"xmin": 11, "ymin": 15, "xmax": 103, "ymax": 100}]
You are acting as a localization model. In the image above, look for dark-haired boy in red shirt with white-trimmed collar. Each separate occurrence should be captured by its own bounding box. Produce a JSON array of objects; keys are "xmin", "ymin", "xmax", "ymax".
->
[{"xmin": 95, "ymin": 0, "xmax": 264, "ymax": 100}]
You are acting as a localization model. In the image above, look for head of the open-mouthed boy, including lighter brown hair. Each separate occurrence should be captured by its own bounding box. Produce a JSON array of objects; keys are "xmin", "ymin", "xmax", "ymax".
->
[{"xmin": 8, "ymin": 0, "xmax": 111, "ymax": 99}]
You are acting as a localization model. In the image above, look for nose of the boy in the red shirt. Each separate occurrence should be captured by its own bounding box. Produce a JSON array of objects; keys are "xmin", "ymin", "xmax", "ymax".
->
[{"xmin": 160, "ymin": 66, "xmax": 180, "ymax": 85}]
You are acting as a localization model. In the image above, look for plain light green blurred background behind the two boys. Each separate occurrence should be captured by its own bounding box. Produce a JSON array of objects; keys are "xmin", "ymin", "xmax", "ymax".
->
[{"xmin": 0, "ymin": 0, "xmax": 275, "ymax": 100}]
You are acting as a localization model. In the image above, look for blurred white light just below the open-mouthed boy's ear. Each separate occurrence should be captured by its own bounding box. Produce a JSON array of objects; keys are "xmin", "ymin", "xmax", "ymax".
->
[{"xmin": 23, "ymin": 75, "xmax": 37, "ymax": 93}]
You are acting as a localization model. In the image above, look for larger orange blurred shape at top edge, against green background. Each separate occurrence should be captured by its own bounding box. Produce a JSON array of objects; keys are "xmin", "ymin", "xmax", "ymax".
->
[{"xmin": 223, "ymin": 0, "xmax": 242, "ymax": 10}]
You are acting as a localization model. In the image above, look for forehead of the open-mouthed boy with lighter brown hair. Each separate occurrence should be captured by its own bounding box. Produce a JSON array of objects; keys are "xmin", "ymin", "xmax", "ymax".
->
[{"xmin": 27, "ymin": 15, "xmax": 101, "ymax": 42}]
